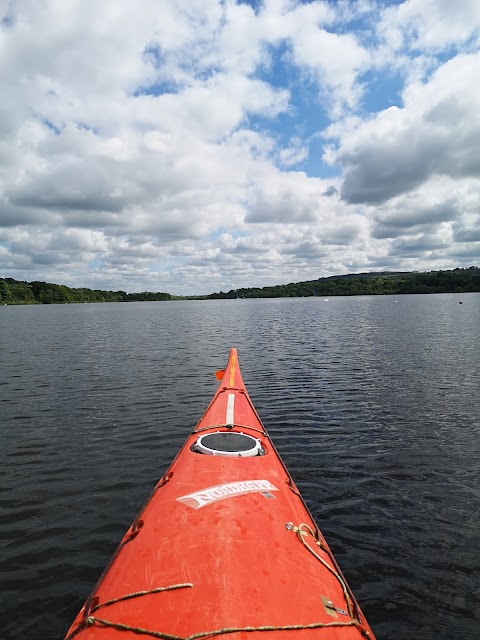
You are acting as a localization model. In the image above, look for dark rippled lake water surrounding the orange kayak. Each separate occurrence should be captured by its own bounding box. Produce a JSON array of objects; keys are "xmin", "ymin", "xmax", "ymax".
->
[{"xmin": 0, "ymin": 293, "xmax": 480, "ymax": 640}]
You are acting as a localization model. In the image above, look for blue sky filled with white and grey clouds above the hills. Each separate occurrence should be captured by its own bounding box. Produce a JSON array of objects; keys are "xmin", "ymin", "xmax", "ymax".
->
[{"xmin": 0, "ymin": 0, "xmax": 480, "ymax": 295}]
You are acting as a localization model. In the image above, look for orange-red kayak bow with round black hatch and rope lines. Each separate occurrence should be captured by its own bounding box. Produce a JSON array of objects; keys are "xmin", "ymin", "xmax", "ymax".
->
[{"xmin": 66, "ymin": 349, "xmax": 374, "ymax": 640}]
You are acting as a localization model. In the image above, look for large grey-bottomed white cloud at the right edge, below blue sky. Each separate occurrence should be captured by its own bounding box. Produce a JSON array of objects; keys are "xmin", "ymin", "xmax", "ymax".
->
[{"xmin": 332, "ymin": 53, "xmax": 480, "ymax": 203}]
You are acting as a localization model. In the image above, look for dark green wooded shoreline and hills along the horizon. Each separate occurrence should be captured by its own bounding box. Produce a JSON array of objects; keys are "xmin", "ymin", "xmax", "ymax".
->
[{"xmin": 0, "ymin": 267, "xmax": 480, "ymax": 304}]
